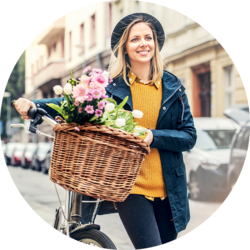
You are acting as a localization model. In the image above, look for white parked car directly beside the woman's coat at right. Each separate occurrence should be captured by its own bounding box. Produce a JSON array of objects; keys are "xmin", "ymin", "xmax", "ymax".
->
[{"xmin": 183, "ymin": 117, "xmax": 239, "ymax": 200}]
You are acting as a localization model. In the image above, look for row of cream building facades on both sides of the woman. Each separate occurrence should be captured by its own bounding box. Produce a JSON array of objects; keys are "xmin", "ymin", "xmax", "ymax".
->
[{"xmin": 24, "ymin": 0, "xmax": 249, "ymax": 141}]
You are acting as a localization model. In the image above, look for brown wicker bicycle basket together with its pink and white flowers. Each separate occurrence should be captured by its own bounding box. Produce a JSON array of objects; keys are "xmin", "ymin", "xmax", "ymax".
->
[{"xmin": 47, "ymin": 67, "xmax": 150, "ymax": 202}]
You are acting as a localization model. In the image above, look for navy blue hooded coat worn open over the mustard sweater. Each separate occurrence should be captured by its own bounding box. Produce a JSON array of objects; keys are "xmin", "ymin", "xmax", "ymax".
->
[{"xmin": 33, "ymin": 70, "xmax": 197, "ymax": 233}]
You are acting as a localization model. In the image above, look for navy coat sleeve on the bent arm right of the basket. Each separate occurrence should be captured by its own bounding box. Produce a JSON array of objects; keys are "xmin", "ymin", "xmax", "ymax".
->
[{"xmin": 150, "ymin": 94, "xmax": 197, "ymax": 152}]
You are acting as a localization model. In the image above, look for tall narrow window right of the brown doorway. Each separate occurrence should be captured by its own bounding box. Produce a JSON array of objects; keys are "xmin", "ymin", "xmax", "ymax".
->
[{"xmin": 224, "ymin": 65, "xmax": 233, "ymax": 109}]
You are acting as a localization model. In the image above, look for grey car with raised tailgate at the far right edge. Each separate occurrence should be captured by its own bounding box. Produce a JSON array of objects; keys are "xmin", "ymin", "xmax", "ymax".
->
[{"xmin": 224, "ymin": 109, "xmax": 250, "ymax": 196}]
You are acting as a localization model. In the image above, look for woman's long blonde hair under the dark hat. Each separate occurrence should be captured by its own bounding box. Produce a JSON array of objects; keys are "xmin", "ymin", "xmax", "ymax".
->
[{"xmin": 108, "ymin": 16, "xmax": 165, "ymax": 86}]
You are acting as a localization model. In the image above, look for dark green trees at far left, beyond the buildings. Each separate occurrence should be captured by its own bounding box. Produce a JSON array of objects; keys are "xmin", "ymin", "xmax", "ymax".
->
[{"xmin": 0, "ymin": 50, "xmax": 25, "ymax": 139}]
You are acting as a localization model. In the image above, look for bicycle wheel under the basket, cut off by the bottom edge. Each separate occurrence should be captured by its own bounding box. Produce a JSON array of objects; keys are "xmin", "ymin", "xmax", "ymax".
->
[{"xmin": 70, "ymin": 229, "xmax": 116, "ymax": 250}]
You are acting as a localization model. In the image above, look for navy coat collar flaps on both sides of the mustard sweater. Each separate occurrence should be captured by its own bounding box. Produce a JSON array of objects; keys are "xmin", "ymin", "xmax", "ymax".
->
[{"xmin": 106, "ymin": 70, "xmax": 185, "ymax": 113}]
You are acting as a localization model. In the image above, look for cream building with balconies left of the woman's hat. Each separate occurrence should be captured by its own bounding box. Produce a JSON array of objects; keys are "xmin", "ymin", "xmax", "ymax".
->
[{"xmin": 23, "ymin": 1, "xmax": 112, "ymax": 142}]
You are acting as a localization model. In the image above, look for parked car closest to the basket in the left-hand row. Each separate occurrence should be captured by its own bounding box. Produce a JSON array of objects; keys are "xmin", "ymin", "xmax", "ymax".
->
[{"xmin": 31, "ymin": 142, "xmax": 52, "ymax": 171}]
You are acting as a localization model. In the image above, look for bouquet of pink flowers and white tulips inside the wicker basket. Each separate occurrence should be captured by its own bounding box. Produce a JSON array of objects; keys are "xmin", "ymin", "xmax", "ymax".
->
[{"xmin": 47, "ymin": 66, "xmax": 147, "ymax": 139}]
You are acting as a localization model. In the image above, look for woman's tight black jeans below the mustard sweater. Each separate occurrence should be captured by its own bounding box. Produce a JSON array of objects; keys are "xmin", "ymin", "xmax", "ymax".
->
[{"xmin": 115, "ymin": 194, "xmax": 177, "ymax": 250}]
